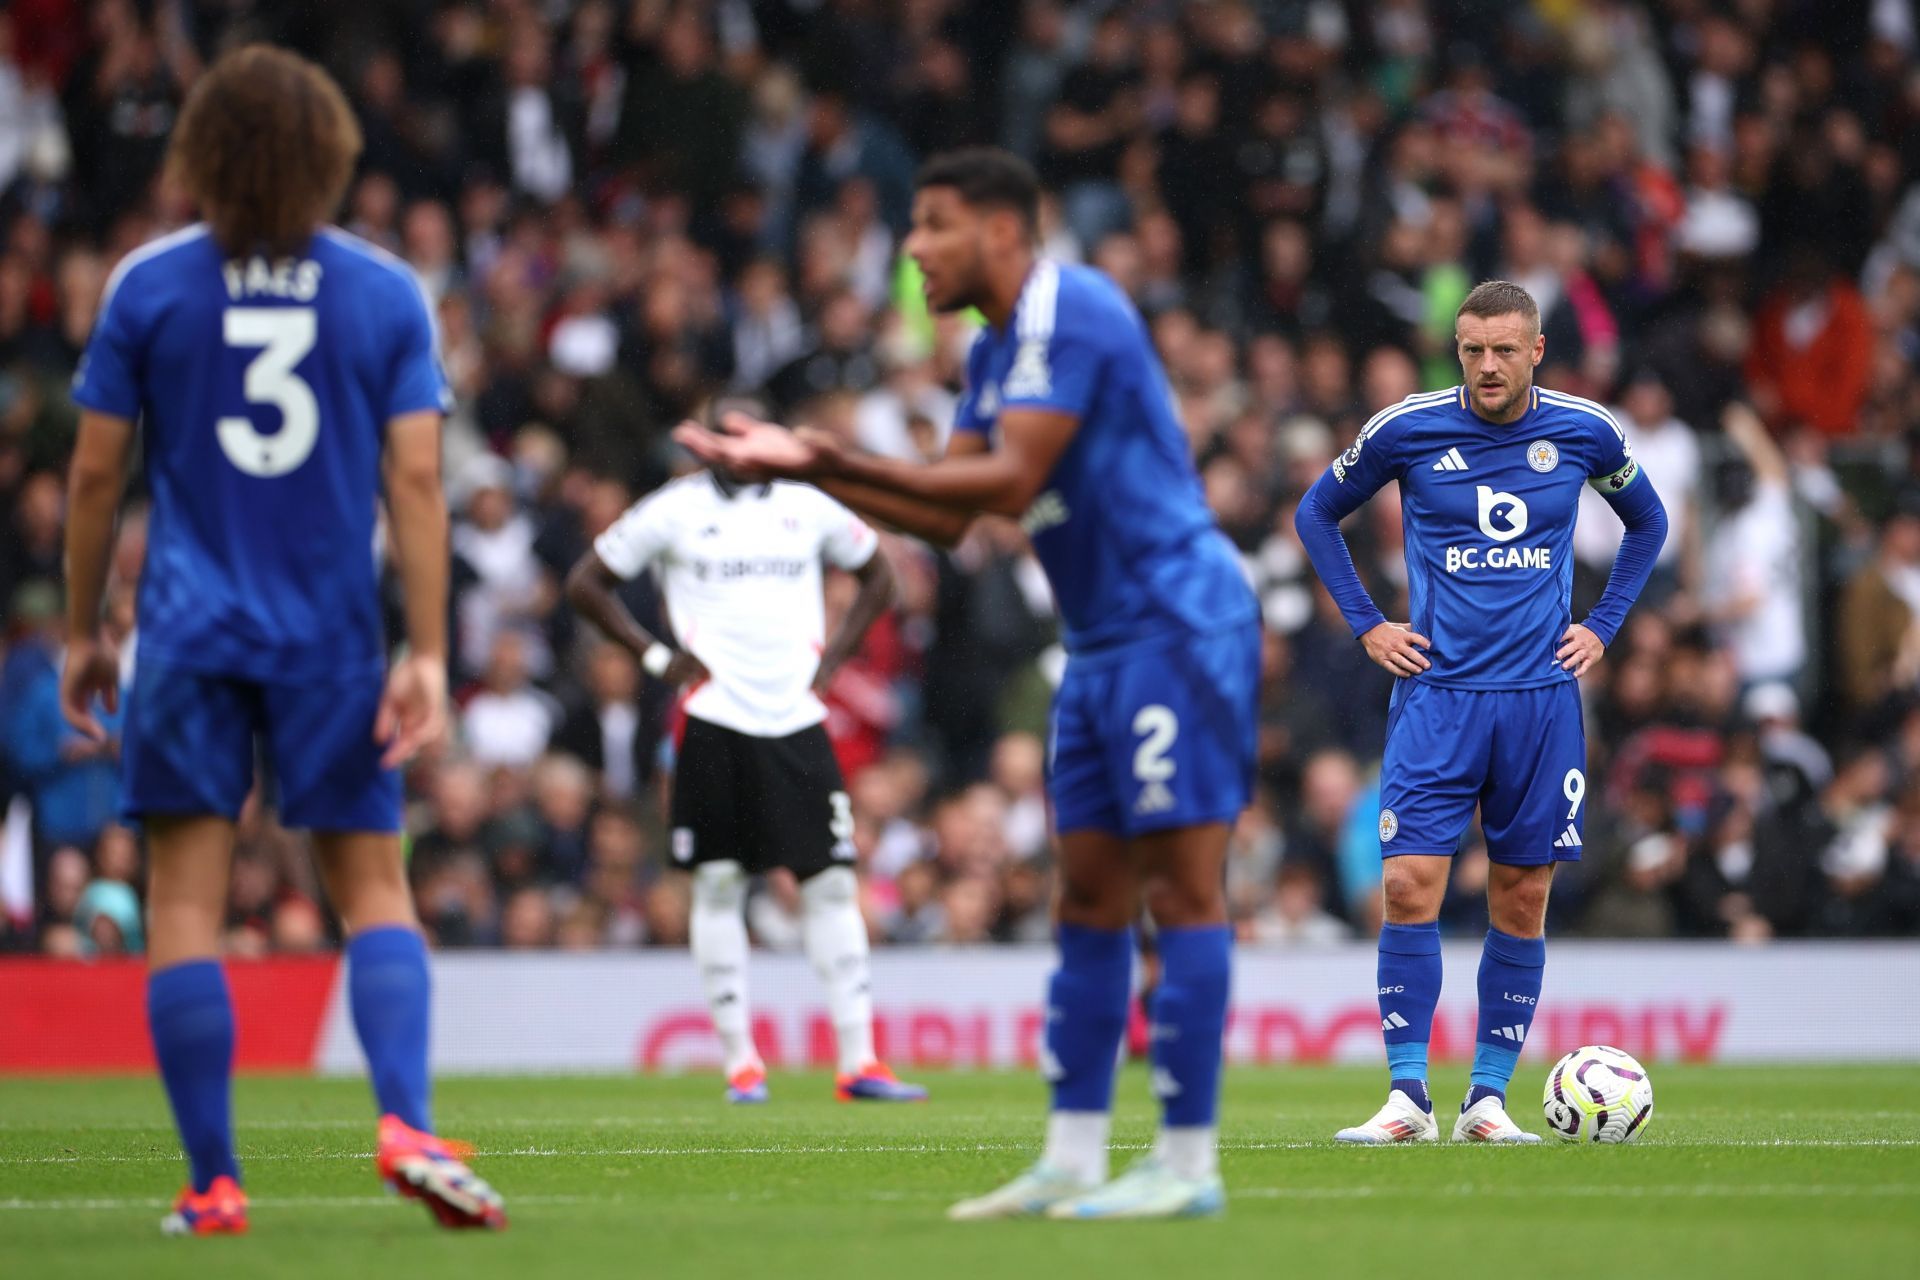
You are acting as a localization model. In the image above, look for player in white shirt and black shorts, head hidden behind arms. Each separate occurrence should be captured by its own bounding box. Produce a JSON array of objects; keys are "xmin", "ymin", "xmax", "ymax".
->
[{"xmin": 566, "ymin": 454, "xmax": 927, "ymax": 1102}]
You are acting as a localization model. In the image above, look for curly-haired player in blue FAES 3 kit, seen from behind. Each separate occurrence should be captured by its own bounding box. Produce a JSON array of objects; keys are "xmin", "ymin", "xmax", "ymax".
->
[{"xmin": 61, "ymin": 46, "xmax": 505, "ymax": 1234}]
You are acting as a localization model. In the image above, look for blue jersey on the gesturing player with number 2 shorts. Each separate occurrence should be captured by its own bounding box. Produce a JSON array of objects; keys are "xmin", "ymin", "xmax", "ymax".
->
[{"xmin": 954, "ymin": 261, "xmax": 1258, "ymax": 652}]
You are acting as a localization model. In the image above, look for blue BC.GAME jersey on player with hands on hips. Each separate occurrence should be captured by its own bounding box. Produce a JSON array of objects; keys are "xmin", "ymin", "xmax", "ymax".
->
[{"xmin": 1317, "ymin": 388, "xmax": 1640, "ymax": 689}]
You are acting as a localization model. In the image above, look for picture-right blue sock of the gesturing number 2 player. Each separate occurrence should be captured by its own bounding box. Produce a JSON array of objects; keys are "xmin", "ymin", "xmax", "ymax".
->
[{"xmin": 1152, "ymin": 925, "xmax": 1233, "ymax": 1128}]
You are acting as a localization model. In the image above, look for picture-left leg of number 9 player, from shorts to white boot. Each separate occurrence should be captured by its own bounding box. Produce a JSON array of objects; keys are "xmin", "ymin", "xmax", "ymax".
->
[{"xmin": 1334, "ymin": 681, "xmax": 1490, "ymax": 1144}]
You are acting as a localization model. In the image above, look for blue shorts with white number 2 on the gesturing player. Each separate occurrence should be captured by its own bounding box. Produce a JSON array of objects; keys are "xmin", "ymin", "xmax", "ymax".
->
[{"xmin": 1046, "ymin": 620, "xmax": 1260, "ymax": 837}]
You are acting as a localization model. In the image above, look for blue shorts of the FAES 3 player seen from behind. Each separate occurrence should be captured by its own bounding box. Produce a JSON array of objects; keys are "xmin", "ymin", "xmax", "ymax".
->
[{"xmin": 121, "ymin": 654, "xmax": 399, "ymax": 831}]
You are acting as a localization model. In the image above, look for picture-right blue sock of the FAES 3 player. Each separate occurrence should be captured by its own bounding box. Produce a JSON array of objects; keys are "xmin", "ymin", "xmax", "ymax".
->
[{"xmin": 348, "ymin": 925, "xmax": 432, "ymax": 1132}]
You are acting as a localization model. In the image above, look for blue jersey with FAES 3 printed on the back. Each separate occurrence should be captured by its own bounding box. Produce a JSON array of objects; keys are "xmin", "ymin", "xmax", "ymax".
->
[{"xmin": 73, "ymin": 226, "xmax": 449, "ymax": 679}]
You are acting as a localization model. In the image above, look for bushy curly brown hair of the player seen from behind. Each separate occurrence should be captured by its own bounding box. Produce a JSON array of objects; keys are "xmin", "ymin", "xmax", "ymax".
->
[{"xmin": 167, "ymin": 44, "xmax": 361, "ymax": 255}]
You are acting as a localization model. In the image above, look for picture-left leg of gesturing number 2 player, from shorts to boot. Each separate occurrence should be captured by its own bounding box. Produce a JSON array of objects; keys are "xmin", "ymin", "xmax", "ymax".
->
[{"xmin": 948, "ymin": 664, "xmax": 1140, "ymax": 1221}]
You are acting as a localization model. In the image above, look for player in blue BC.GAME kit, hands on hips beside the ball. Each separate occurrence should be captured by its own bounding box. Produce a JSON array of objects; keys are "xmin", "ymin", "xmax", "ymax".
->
[{"xmin": 1296, "ymin": 280, "xmax": 1667, "ymax": 1144}]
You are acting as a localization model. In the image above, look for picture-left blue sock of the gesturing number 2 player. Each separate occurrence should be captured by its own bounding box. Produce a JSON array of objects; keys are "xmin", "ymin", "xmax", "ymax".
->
[{"xmin": 1046, "ymin": 925, "xmax": 1133, "ymax": 1113}]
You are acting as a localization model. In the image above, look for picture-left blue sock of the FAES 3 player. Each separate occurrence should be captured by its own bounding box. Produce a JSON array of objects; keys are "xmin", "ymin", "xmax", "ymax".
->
[{"xmin": 146, "ymin": 960, "xmax": 240, "ymax": 1192}]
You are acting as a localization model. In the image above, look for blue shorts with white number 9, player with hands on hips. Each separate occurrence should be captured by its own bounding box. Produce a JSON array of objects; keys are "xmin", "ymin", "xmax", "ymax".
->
[{"xmin": 1380, "ymin": 679, "xmax": 1586, "ymax": 867}]
